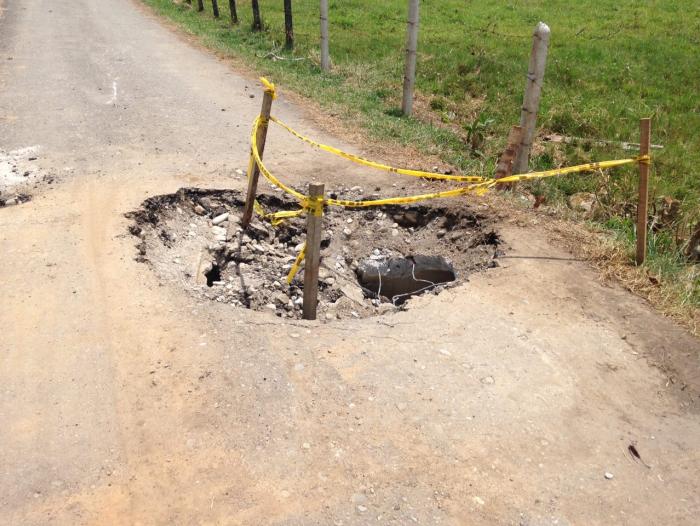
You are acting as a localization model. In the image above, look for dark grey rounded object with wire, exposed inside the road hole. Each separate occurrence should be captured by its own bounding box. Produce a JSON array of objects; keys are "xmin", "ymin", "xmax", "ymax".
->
[{"xmin": 357, "ymin": 256, "xmax": 457, "ymax": 305}]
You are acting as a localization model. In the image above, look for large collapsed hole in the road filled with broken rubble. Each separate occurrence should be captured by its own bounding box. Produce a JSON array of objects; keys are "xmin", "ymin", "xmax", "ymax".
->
[{"xmin": 127, "ymin": 188, "xmax": 499, "ymax": 320}]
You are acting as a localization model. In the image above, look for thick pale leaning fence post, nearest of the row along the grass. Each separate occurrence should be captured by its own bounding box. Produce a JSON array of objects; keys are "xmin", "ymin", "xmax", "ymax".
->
[{"xmin": 513, "ymin": 22, "xmax": 550, "ymax": 174}]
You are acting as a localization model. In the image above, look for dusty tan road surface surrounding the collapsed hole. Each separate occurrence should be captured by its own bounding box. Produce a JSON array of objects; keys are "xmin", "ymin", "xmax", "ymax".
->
[{"xmin": 0, "ymin": 0, "xmax": 700, "ymax": 525}]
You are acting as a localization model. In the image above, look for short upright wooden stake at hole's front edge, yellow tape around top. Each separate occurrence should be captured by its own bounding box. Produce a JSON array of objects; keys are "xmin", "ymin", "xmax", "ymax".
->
[{"xmin": 303, "ymin": 183, "xmax": 325, "ymax": 320}]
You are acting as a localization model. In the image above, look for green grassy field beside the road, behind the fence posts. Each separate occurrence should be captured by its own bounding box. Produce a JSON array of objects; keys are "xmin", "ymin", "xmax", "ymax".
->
[{"xmin": 143, "ymin": 0, "xmax": 700, "ymax": 314}]
